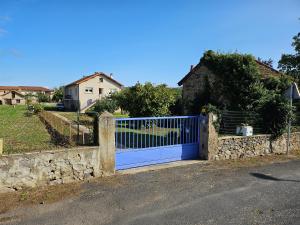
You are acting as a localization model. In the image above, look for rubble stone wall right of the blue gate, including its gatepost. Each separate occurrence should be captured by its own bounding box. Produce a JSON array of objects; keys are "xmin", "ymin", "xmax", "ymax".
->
[{"xmin": 201, "ymin": 114, "xmax": 300, "ymax": 160}]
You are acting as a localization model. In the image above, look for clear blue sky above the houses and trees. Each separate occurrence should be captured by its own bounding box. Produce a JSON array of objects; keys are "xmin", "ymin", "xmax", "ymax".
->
[{"xmin": 0, "ymin": 0, "xmax": 300, "ymax": 88}]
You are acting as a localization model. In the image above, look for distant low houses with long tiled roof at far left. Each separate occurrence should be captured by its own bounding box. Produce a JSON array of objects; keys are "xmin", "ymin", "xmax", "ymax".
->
[{"xmin": 0, "ymin": 86, "xmax": 52, "ymax": 105}]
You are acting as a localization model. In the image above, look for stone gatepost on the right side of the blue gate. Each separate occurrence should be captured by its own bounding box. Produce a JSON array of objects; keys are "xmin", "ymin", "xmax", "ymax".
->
[{"xmin": 200, "ymin": 113, "xmax": 218, "ymax": 160}]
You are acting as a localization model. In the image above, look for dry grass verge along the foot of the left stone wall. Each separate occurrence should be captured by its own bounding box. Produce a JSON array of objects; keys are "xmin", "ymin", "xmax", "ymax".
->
[{"xmin": 0, "ymin": 182, "xmax": 82, "ymax": 214}]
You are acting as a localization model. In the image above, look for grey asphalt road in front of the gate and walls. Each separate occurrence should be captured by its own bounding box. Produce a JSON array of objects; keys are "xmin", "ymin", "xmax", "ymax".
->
[{"xmin": 1, "ymin": 161, "xmax": 300, "ymax": 225}]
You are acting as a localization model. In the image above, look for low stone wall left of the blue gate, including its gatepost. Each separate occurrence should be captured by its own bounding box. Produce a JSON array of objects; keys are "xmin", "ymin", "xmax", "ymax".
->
[{"xmin": 0, "ymin": 113, "xmax": 115, "ymax": 192}]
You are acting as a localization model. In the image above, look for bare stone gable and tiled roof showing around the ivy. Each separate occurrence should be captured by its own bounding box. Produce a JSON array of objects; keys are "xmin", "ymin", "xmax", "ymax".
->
[{"xmin": 178, "ymin": 56, "xmax": 283, "ymax": 113}]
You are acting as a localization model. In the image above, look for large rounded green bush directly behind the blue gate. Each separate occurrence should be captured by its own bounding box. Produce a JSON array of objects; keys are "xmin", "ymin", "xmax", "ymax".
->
[{"xmin": 112, "ymin": 82, "xmax": 175, "ymax": 117}]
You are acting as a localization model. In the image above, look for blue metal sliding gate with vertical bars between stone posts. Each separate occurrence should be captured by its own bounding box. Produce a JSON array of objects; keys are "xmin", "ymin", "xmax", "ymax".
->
[{"xmin": 116, "ymin": 116, "xmax": 203, "ymax": 170}]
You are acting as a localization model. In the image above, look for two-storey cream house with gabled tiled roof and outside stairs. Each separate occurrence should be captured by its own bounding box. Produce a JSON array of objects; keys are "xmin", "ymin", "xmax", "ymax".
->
[{"xmin": 64, "ymin": 72, "xmax": 123, "ymax": 112}]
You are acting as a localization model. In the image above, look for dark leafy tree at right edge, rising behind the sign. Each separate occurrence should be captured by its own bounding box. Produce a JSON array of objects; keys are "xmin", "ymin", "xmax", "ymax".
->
[{"xmin": 278, "ymin": 33, "xmax": 300, "ymax": 82}]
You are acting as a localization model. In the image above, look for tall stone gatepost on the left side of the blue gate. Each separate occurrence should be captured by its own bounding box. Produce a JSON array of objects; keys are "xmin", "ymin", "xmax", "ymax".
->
[{"xmin": 98, "ymin": 112, "xmax": 116, "ymax": 175}]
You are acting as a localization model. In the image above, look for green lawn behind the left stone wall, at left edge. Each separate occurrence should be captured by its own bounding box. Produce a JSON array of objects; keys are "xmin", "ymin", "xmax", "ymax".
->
[{"xmin": 0, "ymin": 105, "xmax": 56, "ymax": 154}]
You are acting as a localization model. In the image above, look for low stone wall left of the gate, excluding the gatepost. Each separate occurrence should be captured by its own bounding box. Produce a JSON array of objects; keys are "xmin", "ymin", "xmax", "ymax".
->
[{"xmin": 0, "ymin": 147, "xmax": 102, "ymax": 192}]
